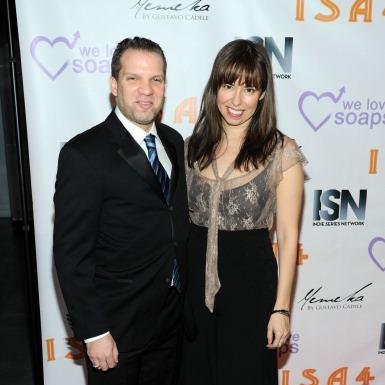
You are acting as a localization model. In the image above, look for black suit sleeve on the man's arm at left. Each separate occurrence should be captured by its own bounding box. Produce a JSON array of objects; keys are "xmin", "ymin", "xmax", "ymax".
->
[{"xmin": 53, "ymin": 144, "xmax": 110, "ymax": 340}]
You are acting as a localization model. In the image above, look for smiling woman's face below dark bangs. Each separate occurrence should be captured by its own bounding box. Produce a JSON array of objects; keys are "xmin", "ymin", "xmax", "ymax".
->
[{"xmin": 217, "ymin": 79, "xmax": 263, "ymax": 129}]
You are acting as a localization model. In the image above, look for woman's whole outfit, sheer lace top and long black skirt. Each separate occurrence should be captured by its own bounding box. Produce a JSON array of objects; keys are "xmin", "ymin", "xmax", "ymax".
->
[{"xmin": 180, "ymin": 137, "xmax": 305, "ymax": 385}]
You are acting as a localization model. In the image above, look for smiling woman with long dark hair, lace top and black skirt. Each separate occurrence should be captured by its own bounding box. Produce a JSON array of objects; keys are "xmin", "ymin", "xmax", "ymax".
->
[{"xmin": 181, "ymin": 40, "xmax": 305, "ymax": 385}]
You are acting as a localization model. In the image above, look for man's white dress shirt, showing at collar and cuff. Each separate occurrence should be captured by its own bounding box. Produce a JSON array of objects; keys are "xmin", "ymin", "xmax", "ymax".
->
[{"xmin": 84, "ymin": 106, "xmax": 172, "ymax": 343}]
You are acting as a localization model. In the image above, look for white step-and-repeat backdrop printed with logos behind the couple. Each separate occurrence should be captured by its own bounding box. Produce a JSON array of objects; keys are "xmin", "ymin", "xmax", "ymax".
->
[{"xmin": 16, "ymin": 0, "xmax": 385, "ymax": 385}]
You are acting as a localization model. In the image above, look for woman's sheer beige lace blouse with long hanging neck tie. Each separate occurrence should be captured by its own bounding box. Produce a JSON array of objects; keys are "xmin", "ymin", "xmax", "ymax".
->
[{"xmin": 186, "ymin": 136, "xmax": 306, "ymax": 311}]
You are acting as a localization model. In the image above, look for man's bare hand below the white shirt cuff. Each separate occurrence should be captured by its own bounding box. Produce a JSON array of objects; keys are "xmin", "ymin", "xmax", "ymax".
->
[{"xmin": 87, "ymin": 334, "xmax": 119, "ymax": 372}]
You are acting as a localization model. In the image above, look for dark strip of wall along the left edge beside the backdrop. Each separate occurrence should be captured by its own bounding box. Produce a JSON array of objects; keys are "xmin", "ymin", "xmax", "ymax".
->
[{"xmin": 0, "ymin": 0, "xmax": 43, "ymax": 385}]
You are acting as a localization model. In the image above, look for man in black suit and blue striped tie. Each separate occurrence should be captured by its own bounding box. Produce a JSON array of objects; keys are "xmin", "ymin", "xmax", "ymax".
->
[{"xmin": 54, "ymin": 37, "xmax": 188, "ymax": 385}]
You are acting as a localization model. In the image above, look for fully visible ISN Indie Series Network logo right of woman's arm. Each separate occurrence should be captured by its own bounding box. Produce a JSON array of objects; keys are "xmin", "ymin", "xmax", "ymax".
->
[{"xmin": 313, "ymin": 189, "xmax": 367, "ymax": 226}]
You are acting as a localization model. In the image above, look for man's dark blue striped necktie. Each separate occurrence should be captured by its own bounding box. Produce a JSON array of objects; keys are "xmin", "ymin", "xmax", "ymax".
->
[{"xmin": 144, "ymin": 134, "xmax": 180, "ymax": 291}]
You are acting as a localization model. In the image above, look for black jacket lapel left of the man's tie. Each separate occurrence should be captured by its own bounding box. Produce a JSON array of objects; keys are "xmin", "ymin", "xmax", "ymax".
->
[{"xmin": 106, "ymin": 112, "xmax": 166, "ymax": 202}]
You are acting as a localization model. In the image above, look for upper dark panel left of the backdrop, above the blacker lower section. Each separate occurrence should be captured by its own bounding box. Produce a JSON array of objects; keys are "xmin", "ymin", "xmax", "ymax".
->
[{"xmin": 0, "ymin": 0, "xmax": 33, "ymax": 222}]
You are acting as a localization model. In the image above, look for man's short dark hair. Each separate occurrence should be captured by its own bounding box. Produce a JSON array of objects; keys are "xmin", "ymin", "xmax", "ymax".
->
[{"xmin": 111, "ymin": 36, "xmax": 167, "ymax": 80}]
